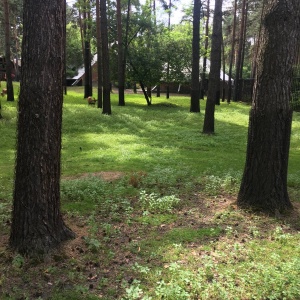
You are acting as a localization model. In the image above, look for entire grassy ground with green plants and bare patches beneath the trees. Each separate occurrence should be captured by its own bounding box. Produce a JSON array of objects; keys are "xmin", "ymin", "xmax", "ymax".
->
[{"xmin": 0, "ymin": 88, "xmax": 300, "ymax": 300}]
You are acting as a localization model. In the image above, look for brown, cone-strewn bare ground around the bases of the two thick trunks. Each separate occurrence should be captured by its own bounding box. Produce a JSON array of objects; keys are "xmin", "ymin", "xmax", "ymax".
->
[{"xmin": 0, "ymin": 172, "xmax": 300, "ymax": 300}]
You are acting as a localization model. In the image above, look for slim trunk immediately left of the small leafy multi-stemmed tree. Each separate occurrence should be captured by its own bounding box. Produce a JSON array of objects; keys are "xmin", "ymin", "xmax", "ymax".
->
[{"xmin": 117, "ymin": 0, "xmax": 125, "ymax": 106}]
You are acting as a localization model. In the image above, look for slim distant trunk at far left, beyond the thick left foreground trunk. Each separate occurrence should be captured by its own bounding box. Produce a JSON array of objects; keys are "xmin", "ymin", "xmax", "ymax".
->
[{"xmin": 3, "ymin": 0, "xmax": 15, "ymax": 101}]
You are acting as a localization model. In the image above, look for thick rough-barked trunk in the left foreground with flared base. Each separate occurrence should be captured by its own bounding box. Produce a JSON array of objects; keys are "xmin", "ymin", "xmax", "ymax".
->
[{"xmin": 10, "ymin": 0, "xmax": 74, "ymax": 255}]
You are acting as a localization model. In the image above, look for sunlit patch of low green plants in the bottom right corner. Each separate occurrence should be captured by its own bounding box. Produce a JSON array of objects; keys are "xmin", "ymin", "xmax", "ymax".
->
[{"xmin": 125, "ymin": 229, "xmax": 300, "ymax": 300}]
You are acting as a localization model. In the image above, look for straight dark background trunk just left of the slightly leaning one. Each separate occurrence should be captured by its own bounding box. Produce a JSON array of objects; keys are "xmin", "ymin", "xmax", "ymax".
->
[{"xmin": 190, "ymin": 0, "xmax": 201, "ymax": 113}]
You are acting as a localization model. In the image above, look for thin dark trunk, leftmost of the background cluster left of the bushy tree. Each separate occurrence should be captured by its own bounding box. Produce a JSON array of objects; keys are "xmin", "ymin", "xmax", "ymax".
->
[{"xmin": 83, "ymin": 0, "xmax": 93, "ymax": 98}]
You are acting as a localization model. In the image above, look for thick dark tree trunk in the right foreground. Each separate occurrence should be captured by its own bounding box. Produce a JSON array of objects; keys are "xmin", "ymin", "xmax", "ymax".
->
[{"xmin": 238, "ymin": 0, "xmax": 300, "ymax": 213}]
